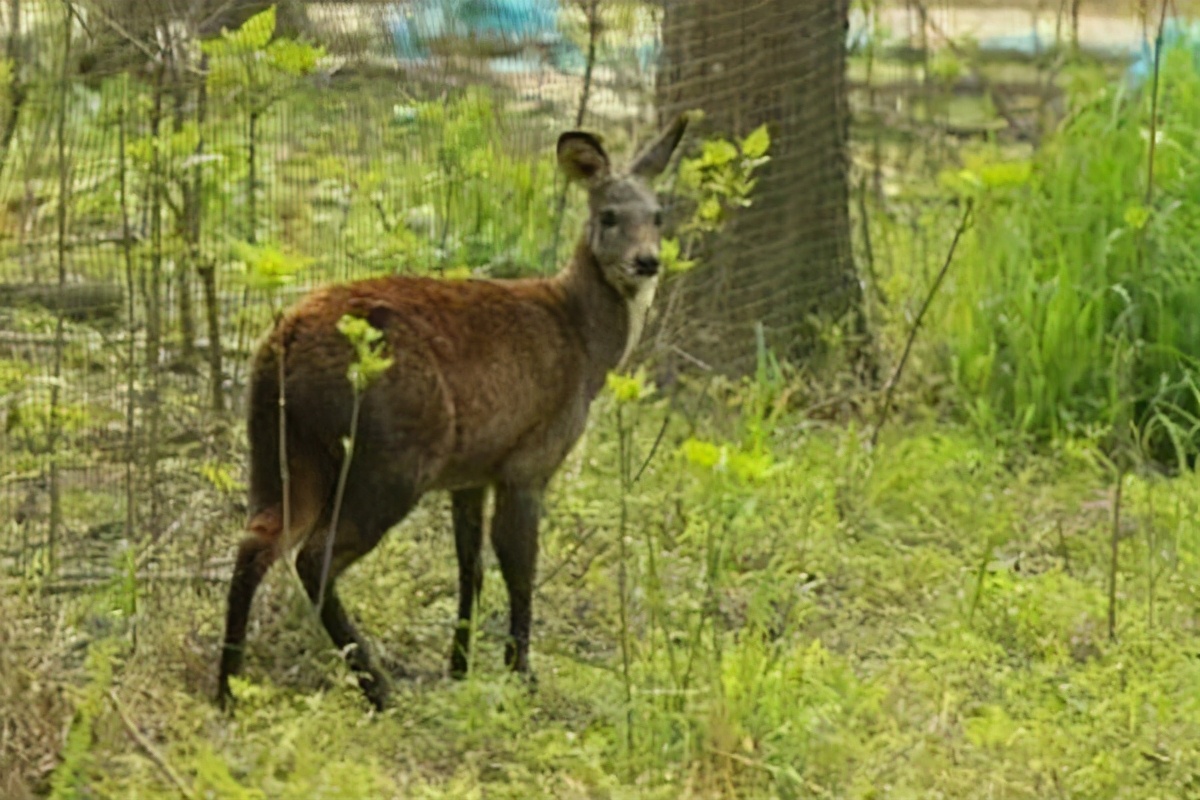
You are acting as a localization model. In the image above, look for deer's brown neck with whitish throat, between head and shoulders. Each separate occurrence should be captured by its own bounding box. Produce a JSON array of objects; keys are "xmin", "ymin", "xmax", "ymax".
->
[{"xmin": 560, "ymin": 236, "xmax": 658, "ymax": 390}]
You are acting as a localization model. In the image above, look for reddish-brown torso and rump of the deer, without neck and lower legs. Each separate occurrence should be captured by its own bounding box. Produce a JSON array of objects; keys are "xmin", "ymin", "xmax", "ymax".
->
[{"xmin": 248, "ymin": 277, "xmax": 599, "ymax": 551}]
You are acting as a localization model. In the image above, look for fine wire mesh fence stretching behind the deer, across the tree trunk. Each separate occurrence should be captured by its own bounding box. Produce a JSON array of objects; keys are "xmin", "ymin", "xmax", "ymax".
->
[{"xmin": 0, "ymin": 0, "xmax": 1190, "ymax": 591}]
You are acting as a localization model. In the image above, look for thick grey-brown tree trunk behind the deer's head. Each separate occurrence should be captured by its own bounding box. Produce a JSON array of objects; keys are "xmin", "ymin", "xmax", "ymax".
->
[{"xmin": 658, "ymin": 0, "xmax": 862, "ymax": 372}]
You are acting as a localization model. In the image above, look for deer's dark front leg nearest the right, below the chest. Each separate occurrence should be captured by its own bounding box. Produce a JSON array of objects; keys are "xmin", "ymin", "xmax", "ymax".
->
[{"xmin": 492, "ymin": 486, "xmax": 541, "ymax": 674}]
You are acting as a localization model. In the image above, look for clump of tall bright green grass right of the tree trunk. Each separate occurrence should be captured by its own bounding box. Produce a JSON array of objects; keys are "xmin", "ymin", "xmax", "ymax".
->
[{"xmin": 931, "ymin": 54, "xmax": 1200, "ymax": 463}]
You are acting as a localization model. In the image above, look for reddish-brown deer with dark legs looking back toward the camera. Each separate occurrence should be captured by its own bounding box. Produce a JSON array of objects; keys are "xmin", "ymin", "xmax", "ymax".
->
[{"xmin": 217, "ymin": 116, "xmax": 688, "ymax": 708}]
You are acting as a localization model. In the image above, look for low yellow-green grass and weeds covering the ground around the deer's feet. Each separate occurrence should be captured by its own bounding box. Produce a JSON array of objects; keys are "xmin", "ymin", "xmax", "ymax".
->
[{"xmin": 4, "ymin": 379, "xmax": 1200, "ymax": 798}]
